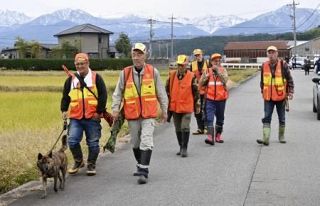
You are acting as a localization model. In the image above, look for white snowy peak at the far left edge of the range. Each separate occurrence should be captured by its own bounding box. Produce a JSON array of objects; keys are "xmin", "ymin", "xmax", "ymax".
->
[{"xmin": 0, "ymin": 10, "xmax": 31, "ymax": 26}]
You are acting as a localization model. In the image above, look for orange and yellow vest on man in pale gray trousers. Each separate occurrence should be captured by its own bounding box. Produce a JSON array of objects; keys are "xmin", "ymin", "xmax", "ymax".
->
[{"xmin": 124, "ymin": 64, "xmax": 158, "ymax": 120}]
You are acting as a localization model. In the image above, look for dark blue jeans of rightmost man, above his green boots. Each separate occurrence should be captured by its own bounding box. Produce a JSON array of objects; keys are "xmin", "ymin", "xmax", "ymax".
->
[{"xmin": 262, "ymin": 100, "xmax": 286, "ymax": 126}]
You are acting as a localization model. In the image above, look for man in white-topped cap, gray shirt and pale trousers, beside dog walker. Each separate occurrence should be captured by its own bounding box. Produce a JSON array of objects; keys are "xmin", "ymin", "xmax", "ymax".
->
[{"xmin": 112, "ymin": 43, "xmax": 168, "ymax": 184}]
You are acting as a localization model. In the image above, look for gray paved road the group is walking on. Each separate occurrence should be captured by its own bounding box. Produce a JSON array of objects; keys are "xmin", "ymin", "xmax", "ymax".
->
[{"xmin": 8, "ymin": 71, "xmax": 320, "ymax": 206}]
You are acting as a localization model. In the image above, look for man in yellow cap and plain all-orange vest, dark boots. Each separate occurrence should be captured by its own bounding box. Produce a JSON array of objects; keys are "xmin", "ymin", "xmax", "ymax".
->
[{"xmin": 166, "ymin": 55, "xmax": 200, "ymax": 157}]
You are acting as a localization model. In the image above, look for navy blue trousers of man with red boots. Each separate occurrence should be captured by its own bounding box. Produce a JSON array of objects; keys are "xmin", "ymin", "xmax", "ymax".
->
[{"xmin": 206, "ymin": 99, "xmax": 226, "ymax": 127}]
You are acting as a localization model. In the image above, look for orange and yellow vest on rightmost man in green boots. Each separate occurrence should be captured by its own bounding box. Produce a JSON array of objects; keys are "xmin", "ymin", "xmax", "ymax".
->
[{"xmin": 262, "ymin": 61, "xmax": 287, "ymax": 101}]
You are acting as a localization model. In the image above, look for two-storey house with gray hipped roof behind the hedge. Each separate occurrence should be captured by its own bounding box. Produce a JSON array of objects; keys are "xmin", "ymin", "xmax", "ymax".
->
[{"xmin": 54, "ymin": 24, "xmax": 113, "ymax": 59}]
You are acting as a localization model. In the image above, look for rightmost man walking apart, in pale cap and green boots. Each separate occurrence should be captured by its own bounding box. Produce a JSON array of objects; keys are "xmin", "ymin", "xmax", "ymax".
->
[{"xmin": 257, "ymin": 46, "xmax": 294, "ymax": 146}]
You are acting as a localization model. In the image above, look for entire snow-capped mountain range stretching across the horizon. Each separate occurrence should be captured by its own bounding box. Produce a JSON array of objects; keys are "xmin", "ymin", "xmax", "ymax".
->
[{"xmin": 0, "ymin": 6, "xmax": 320, "ymax": 48}]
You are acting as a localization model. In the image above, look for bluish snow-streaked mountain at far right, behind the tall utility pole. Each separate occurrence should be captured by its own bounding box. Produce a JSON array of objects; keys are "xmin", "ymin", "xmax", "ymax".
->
[{"xmin": 214, "ymin": 6, "xmax": 320, "ymax": 35}]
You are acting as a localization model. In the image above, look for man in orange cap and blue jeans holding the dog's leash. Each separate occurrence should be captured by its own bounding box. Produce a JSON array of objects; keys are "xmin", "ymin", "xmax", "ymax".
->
[{"xmin": 61, "ymin": 53, "xmax": 107, "ymax": 176}]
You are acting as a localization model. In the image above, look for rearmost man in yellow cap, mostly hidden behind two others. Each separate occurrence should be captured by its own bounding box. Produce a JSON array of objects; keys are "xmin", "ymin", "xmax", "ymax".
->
[{"xmin": 191, "ymin": 49, "xmax": 209, "ymax": 135}]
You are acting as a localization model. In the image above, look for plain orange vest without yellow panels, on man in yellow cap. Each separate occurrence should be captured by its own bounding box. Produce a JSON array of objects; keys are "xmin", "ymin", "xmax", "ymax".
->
[{"xmin": 169, "ymin": 71, "xmax": 194, "ymax": 113}]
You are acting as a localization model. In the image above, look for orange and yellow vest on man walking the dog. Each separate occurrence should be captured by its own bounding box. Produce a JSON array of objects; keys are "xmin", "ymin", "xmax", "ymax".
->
[{"xmin": 69, "ymin": 71, "xmax": 98, "ymax": 119}]
